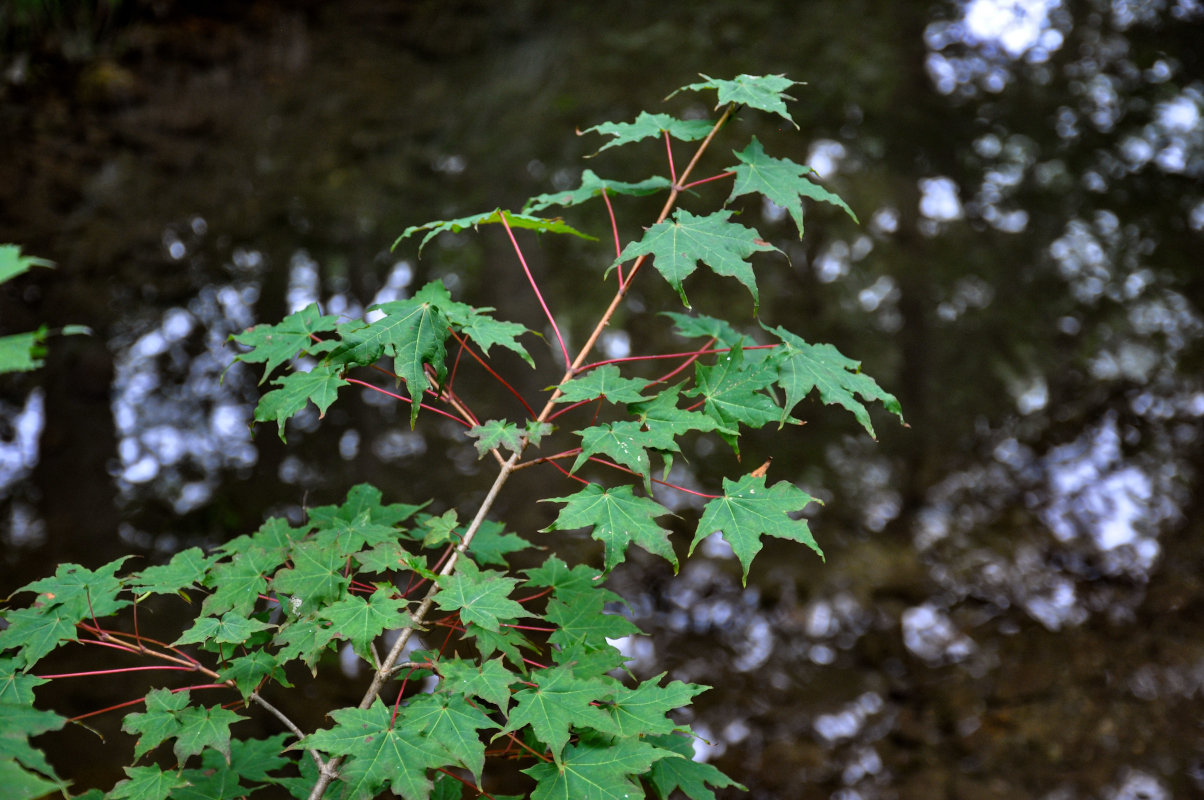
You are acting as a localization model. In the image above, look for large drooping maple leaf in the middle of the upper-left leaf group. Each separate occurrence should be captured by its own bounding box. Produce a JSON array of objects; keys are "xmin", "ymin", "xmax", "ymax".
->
[{"xmin": 330, "ymin": 298, "xmax": 450, "ymax": 428}]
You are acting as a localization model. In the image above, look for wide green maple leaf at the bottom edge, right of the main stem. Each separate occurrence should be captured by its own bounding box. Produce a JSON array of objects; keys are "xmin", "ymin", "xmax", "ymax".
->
[{"xmin": 523, "ymin": 739, "xmax": 679, "ymax": 800}]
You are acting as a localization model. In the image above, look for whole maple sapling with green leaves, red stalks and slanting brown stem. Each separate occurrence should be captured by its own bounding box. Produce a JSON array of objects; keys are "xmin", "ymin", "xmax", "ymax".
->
[{"xmin": 0, "ymin": 75, "xmax": 902, "ymax": 800}]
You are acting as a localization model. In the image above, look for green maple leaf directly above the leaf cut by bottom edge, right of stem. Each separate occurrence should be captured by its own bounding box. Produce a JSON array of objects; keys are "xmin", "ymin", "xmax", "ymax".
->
[{"xmin": 495, "ymin": 666, "xmax": 618, "ymax": 765}]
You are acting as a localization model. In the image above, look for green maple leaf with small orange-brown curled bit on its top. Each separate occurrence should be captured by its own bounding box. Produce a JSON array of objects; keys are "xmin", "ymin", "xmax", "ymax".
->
[{"xmin": 690, "ymin": 475, "xmax": 824, "ymax": 584}]
